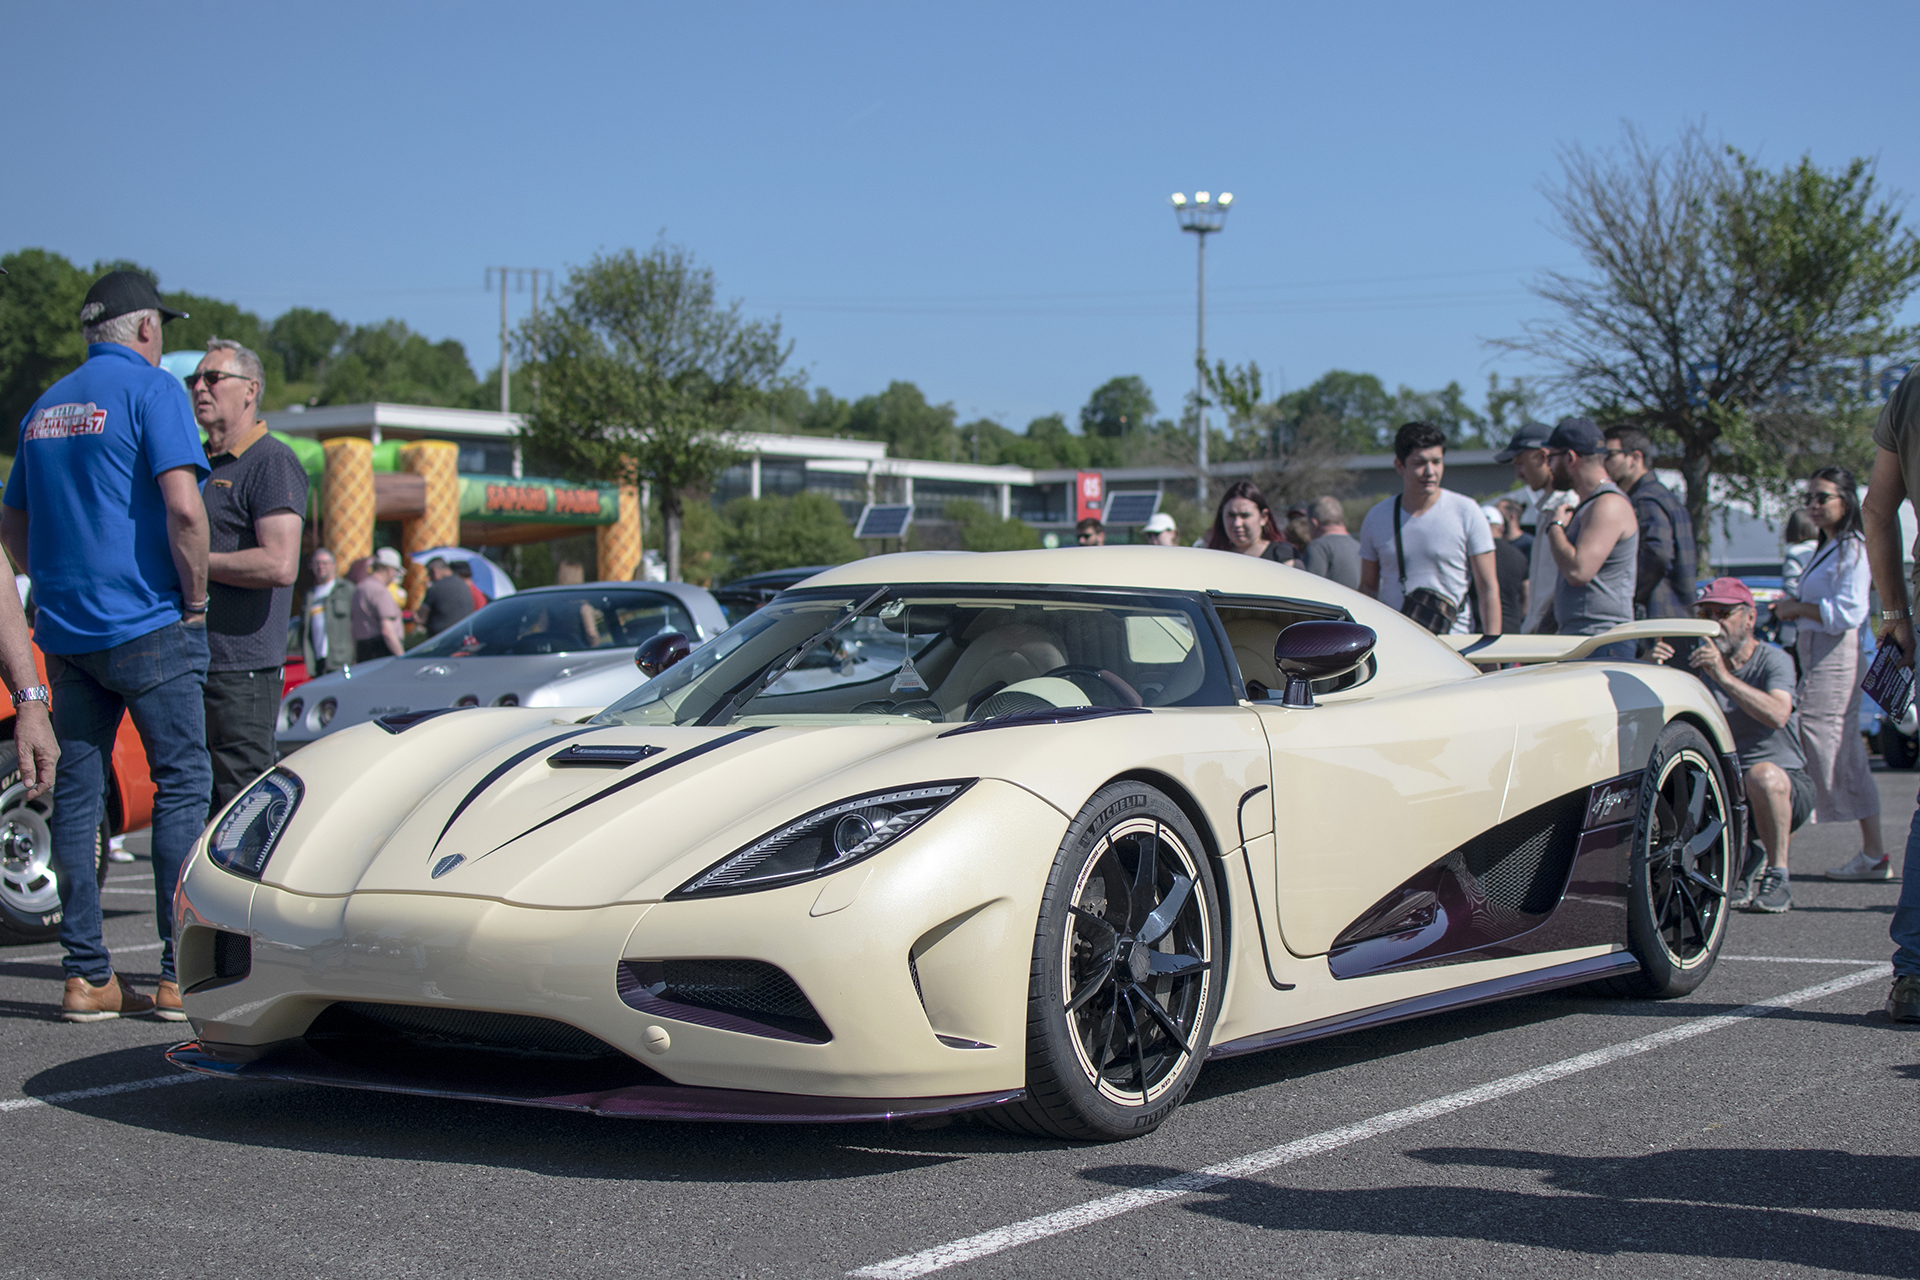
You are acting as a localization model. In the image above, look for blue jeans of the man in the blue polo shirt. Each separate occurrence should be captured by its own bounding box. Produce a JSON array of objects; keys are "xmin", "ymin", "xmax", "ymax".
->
[{"xmin": 46, "ymin": 622, "xmax": 213, "ymax": 983}]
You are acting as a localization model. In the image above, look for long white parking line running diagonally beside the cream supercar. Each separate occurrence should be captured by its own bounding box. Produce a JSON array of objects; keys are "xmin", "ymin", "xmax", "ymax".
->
[{"xmin": 847, "ymin": 963, "xmax": 1893, "ymax": 1280}]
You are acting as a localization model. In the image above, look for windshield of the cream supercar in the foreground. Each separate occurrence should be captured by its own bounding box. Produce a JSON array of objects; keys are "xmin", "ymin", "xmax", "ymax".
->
[{"xmin": 595, "ymin": 585, "xmax": 1233, "ymax": 723}]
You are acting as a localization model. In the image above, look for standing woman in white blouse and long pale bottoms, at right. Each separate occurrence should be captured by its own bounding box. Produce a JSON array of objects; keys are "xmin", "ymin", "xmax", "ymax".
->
[{"xmin": 1774, "ymin": 466, "xmax": 1891, "ymax": 881}]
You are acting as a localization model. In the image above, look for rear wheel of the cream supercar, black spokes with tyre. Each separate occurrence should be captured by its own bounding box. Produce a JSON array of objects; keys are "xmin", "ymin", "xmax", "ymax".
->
[{"xmin": 1607, "ymin": 723, "xmax": 1738, "ymax": 1000}]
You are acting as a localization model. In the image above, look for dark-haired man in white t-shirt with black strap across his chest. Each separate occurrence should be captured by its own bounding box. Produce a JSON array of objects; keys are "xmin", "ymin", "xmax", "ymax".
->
[{"xmin": 1359, "ymin": 422, "xmax": 1500, "ymax": 635}]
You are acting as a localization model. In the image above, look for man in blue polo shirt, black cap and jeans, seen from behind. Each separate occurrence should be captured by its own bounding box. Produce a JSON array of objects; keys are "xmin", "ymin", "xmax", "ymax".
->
[{"xmin": 0, "ymin": 271, "xmax": 213, "ymax": 1023}]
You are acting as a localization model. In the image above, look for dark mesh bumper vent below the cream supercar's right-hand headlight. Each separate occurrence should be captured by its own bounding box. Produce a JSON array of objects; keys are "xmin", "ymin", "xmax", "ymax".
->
[{"xmin": 618, "ymin": 960, "xmax": 833, "ymax": 1044}]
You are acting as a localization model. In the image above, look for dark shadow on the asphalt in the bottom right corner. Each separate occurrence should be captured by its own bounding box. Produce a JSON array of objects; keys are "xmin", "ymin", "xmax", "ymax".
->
[{"xmin": 1085, "ymin": 1148, "xmax": 1920, "ymax": 1280}]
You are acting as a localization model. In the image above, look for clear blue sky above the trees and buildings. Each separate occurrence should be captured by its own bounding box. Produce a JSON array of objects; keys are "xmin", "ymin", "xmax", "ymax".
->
[{"xmin": 0, "ymin": 0, "xmax": 1920, "ymax": 430}]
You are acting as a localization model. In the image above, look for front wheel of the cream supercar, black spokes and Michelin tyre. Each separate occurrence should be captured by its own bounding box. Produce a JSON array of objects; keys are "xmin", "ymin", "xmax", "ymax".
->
[{"xmin": 989, "ymin": 783, "xmax": 1223, "ymax": 1140}]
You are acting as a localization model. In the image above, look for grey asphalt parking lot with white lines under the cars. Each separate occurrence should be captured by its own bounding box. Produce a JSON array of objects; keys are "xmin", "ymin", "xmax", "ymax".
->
[{"xmin": 0, "ymin": 773, "xmax": 1920, "ymax": 1280}]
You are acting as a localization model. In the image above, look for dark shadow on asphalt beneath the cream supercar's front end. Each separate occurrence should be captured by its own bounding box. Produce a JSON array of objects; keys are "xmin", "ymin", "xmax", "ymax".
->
[{"xmin": 21, "ymin": 1027, "xmax": 1036, "ymax": 1184}]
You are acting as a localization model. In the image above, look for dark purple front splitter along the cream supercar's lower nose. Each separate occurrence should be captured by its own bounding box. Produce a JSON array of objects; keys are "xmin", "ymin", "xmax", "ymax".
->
[{"xmin": 167, "ymin": 1040, "xmax": 1025, "ymax": 1125}]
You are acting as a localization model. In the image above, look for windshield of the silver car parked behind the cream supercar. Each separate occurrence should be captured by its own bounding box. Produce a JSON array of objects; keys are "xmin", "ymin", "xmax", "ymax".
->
[{"xmin": 407, "ymin": 587, "xmax": 695, "ymax": 658}]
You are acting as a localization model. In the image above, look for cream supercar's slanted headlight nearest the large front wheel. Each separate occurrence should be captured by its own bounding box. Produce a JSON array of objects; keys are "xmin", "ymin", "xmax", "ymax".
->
[{"xmin": 666, "ymin": 777, "xmax": 975, "ymax": 898}]
